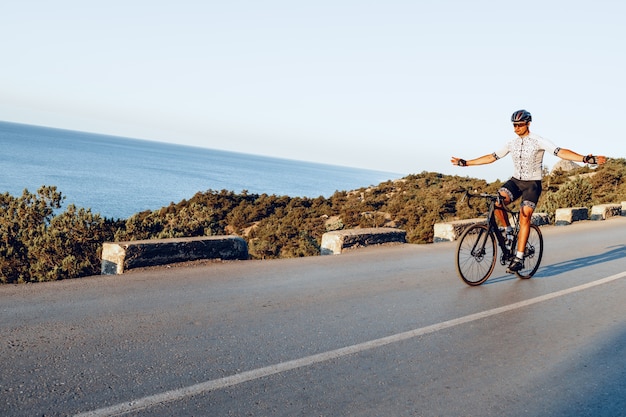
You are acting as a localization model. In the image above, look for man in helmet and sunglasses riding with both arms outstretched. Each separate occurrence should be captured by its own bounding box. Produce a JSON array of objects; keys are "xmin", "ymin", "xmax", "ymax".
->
[{"xmin": 450, "ymin": 110, "xmax": 606, "ymax": 272}]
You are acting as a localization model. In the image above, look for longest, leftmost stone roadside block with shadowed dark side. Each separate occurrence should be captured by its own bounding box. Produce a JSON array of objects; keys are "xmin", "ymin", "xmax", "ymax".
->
[{"xmin": 101, "ymin": 236, "xmax": 248, "ymax": 275}]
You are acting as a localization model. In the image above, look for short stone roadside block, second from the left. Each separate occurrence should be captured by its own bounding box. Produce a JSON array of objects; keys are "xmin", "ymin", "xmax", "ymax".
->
[{"xmin": 320, "ymin": 227, "xmax": 406, "ymax": 255}]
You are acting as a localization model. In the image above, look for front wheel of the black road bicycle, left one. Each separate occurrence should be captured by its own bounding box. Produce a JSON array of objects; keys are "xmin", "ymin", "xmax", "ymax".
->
[{"xmin": 456, "ymin": 224, "xmax": 497, "ymax": 286}]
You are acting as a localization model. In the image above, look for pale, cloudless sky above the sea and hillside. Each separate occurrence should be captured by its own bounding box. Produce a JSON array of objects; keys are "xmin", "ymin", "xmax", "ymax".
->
[{"xmin": 0, "ymin": 0, "xmax": 626, "ymax": 181}]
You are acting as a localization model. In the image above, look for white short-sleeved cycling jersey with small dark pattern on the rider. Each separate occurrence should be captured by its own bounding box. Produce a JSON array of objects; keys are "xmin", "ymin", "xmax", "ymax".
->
[{"xmin": 493, "ymin": 132, "xmax": 561, "ymax": 181}]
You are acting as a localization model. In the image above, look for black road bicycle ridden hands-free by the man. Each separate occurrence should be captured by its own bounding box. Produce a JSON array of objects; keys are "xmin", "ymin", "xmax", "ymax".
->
[{"xmin": 456, "ymin": 190, "xmax": 543, "ymax": 286}]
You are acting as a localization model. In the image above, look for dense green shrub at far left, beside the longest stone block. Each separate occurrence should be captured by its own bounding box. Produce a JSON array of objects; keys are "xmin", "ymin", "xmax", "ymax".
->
[{"xmin": 0, "ymin": 186, "xmax": 115, "ymax": 283}]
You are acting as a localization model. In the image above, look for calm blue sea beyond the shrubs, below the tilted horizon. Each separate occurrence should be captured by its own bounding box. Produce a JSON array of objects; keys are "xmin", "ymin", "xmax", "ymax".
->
[{"xmin": 0, "ymin": 122, "xmax": 403, "ymax": 219}]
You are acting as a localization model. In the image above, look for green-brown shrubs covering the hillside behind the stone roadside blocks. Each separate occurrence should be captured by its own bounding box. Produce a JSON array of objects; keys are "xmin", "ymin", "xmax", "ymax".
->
[{"xmin": 0, "ymin": 159, "xmax": 626, "ymax": 283}]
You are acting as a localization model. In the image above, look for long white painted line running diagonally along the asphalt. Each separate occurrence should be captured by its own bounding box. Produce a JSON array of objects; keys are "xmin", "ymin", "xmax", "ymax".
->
[{"xmin": 76, "ymin": 271, "xmax": 626, "ymax": 417}]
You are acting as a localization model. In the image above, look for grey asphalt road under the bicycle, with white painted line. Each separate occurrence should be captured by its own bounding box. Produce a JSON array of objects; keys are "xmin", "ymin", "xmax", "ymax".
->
[{"xmin": 0, "ymin": 217, "xmax": 626, "ymax": 417}]
